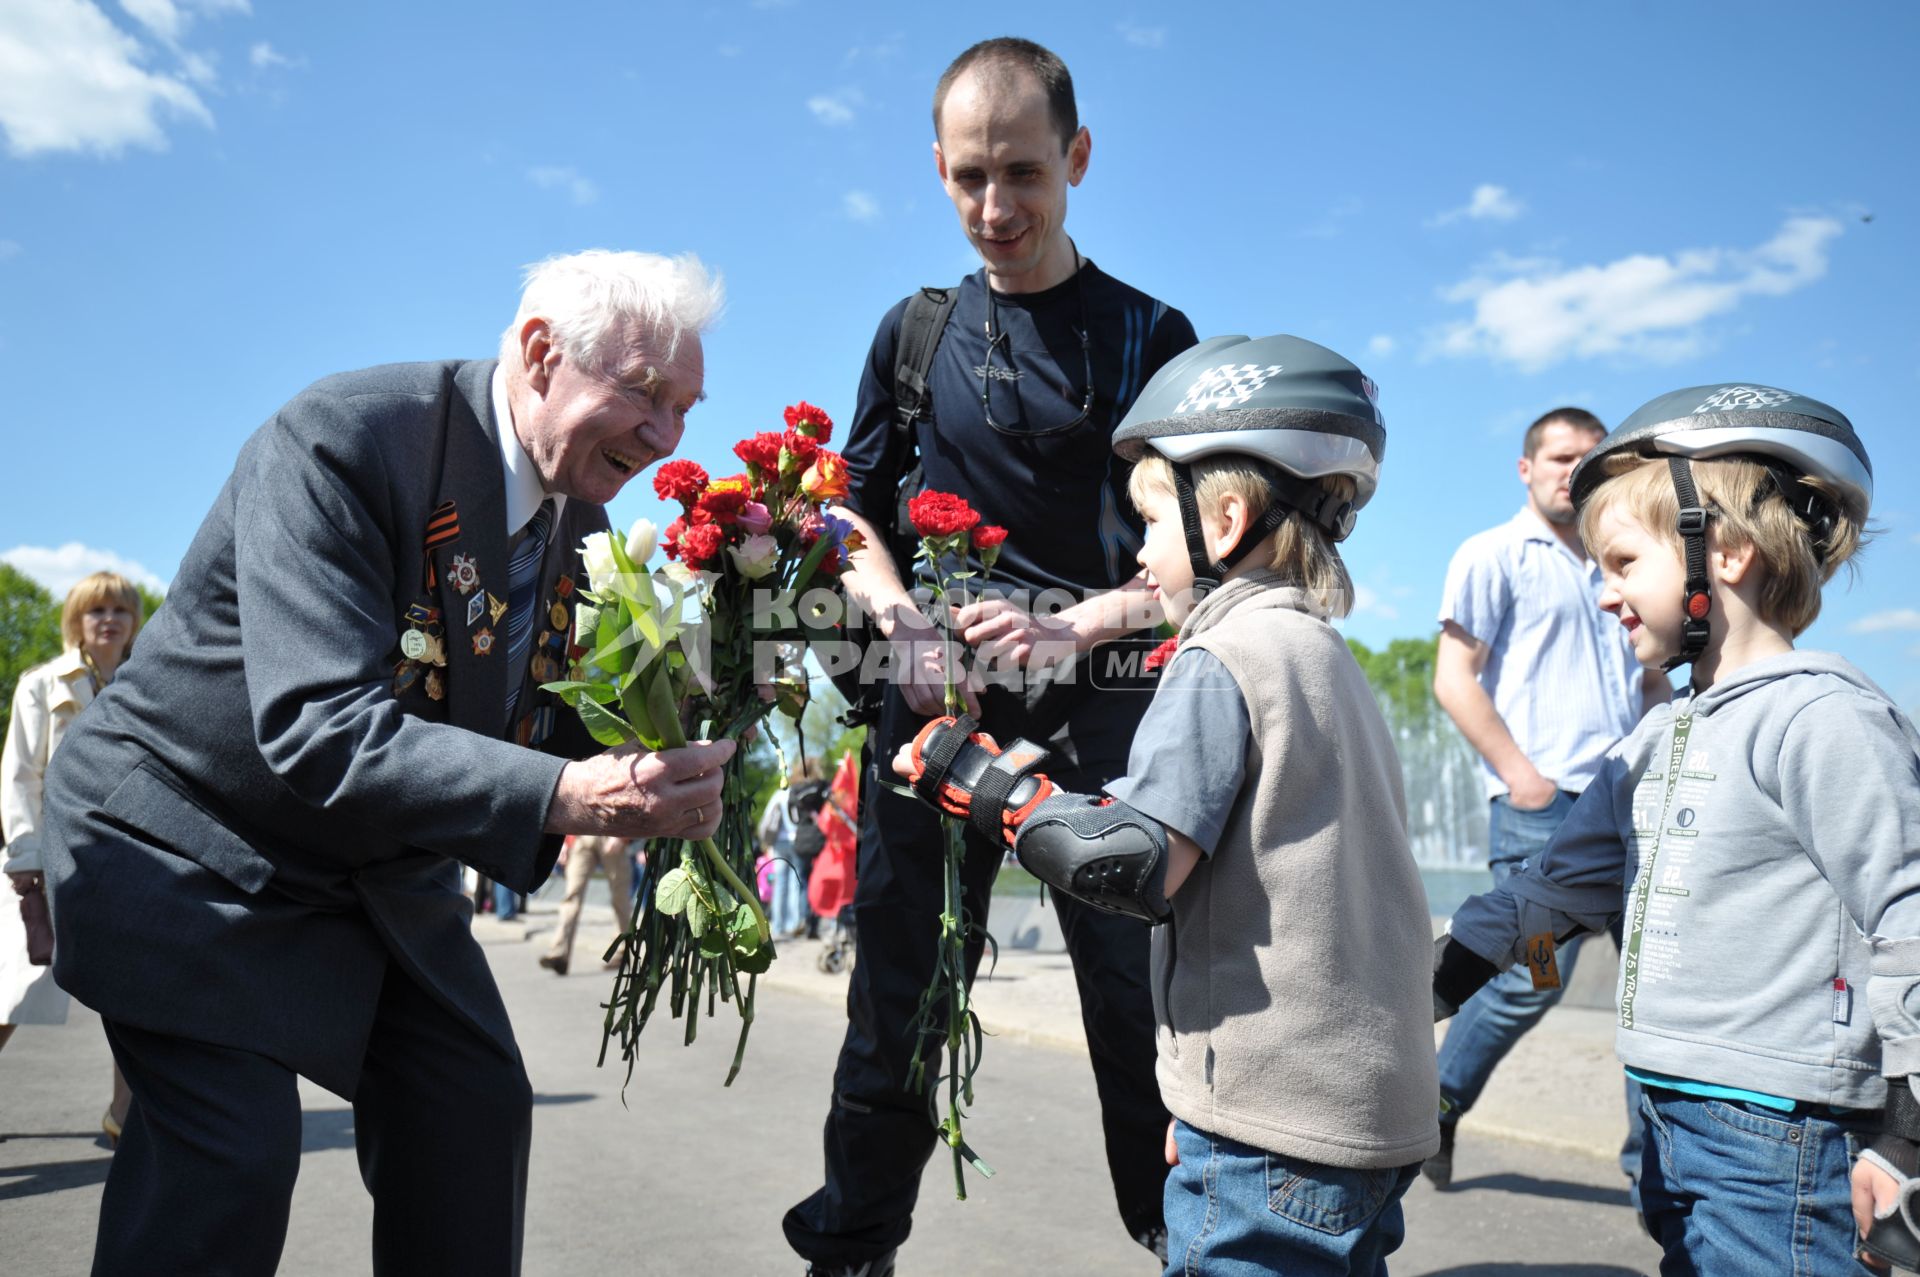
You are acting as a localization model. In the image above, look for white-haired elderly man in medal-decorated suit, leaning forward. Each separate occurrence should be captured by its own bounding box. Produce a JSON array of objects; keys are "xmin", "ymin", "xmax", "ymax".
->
[{"xmin": 44, "ymin": 252, "xmax": 733, "ymax": 1275}]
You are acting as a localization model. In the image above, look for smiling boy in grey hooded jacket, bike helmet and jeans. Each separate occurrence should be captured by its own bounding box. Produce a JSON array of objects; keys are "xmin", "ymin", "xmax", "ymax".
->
[{"xmin": 1434, "ymin": 384, "xmax": 1920, "ymax": 1277}]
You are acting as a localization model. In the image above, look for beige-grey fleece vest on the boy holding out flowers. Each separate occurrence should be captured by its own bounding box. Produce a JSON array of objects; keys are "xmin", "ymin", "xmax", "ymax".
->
[{"xmin": 1154, "ymin": 572, "xmax": 1440, "ymax": 1168}]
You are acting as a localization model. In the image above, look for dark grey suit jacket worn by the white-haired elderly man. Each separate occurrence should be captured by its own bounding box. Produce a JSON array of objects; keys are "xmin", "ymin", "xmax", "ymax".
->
[{"xmin": 44, "ymin": 361, "xmax": 607, "ymax": 1096}]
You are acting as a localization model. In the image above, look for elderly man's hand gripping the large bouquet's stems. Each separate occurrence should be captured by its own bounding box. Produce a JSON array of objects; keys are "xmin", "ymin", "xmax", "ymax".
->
[{"xmin": 547, "ymin": 741, "xmax": 733, "ymax": 839}]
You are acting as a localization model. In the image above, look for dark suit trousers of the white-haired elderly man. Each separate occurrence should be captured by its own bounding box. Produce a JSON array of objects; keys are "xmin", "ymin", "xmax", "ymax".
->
[{"xmin": 94, "ymin": 964, "xmax": 534, "ymax": 1277}]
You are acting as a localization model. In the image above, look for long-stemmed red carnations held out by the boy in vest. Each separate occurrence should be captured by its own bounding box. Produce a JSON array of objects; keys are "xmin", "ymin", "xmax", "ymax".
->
[{"xmin": 906, "ymin": 492, "xmax": 1006, "ymax": 1202}]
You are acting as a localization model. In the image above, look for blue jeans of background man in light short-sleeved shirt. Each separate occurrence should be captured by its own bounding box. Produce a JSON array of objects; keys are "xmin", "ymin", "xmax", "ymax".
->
[{"xmin": 1440, "ymin": 789, "xmax": 1586, "ymax": 1118}]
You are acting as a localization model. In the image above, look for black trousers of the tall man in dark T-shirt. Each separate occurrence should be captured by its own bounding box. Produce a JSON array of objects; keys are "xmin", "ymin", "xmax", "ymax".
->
[{"xmin": 783, "ymin": 702, "xmax": 1167, "ymax": 1265}]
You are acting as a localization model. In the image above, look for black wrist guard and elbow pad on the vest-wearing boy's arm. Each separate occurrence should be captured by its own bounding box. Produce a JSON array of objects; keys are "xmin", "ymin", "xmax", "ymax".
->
[{"xmin": 908, "ymin": 716, "xmax": 1173, "ymax": 924}]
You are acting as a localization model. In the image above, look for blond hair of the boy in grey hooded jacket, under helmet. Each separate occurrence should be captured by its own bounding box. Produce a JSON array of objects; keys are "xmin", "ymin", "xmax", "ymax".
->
[{"xmin": 1580, "ymin": 453, "xmax": 1866, "ymax": 638}]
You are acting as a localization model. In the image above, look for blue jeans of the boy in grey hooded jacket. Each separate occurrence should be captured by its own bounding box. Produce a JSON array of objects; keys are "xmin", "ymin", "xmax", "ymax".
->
[{"xmin": 1640, "ymin": 1089, "xmax": 1878, "ymax": 1277}]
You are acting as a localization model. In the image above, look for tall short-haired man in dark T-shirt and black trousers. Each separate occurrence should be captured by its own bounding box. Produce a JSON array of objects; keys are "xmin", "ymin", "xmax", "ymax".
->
[{"xmin": 785, "ymin": 38, "xmax": 1194, "ymax": 1277}]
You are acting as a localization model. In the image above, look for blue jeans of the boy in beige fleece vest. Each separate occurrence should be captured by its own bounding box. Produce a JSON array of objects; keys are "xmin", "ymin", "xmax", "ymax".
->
[{"xmin": 1165, "ymin": 1121, "xmax": 1419, "ymax": 1277}]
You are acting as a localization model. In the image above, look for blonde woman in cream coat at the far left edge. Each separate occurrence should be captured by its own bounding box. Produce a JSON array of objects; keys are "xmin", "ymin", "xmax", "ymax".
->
[{"xmin": 0, "ymin": 572, "xmax": 140, "ymax": 1143}]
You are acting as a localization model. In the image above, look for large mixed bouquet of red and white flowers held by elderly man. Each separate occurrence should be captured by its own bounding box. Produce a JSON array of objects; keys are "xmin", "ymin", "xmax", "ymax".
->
[{"xmin": 547, "ymin": 403, "xmax": 860, "ymax": 1085}]
